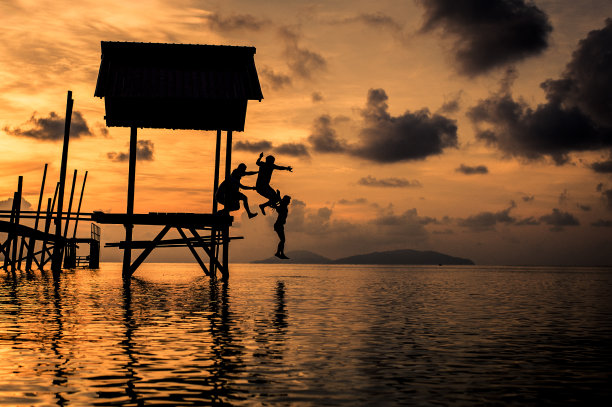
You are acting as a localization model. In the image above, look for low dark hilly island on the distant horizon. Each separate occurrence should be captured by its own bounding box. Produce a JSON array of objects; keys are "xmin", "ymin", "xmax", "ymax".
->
[{"xmin": 251, "ymin": 249, "xmax": 475, "ymax": 265}]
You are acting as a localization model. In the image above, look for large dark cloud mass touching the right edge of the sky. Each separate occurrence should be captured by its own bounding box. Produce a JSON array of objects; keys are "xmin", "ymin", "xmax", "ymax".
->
[{"xmin": 468, "ymin": 19, "xmax": 612, "ymax": 164}]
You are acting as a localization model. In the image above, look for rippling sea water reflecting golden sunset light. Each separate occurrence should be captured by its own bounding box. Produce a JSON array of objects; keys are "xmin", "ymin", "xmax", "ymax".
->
[{"xmin": 0, "ymin": 263, "xmax": 612, "ymax": 406}]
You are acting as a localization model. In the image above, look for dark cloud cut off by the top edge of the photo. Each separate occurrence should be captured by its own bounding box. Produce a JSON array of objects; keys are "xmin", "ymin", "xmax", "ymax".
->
[{"xmin": 420, "ymin": 0, "xmax": 552, "ymax": 76}]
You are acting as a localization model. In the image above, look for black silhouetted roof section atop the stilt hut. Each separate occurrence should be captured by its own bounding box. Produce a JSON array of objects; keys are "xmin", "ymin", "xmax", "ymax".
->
[{"xmin": 94, "ymin": 41, "xmax": 263, "ymax": 131}]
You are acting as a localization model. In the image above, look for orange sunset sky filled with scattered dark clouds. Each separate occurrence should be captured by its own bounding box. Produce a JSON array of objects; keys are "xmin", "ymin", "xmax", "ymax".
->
[{"xmin": 0, "ymin": 0, "xmax": 612, "ymax": 265}]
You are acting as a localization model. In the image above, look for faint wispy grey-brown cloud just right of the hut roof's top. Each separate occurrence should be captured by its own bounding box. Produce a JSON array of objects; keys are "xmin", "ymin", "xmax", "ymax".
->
[{"xmin": 279, "ymin": 26, "xmax": 327, "ymax": 79}]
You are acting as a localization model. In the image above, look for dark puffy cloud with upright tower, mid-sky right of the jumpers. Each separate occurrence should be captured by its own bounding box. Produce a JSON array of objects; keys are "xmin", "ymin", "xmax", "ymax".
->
[{"xmin": 308, "ymin": 89, "xmax": 457, "ymax": 163}]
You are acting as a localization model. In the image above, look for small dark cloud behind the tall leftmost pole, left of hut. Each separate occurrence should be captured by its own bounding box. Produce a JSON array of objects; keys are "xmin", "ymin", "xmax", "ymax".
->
[{"xmin": 3, "ymin": 110, "xmax": 94, "ymax": 141}]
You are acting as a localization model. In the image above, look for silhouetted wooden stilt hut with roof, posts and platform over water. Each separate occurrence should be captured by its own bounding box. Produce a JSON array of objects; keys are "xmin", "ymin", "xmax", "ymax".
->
[{"xmin": 94, "ymin": 42, "xmax": 263, "ymax": 277}]
